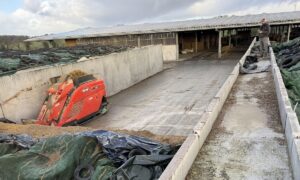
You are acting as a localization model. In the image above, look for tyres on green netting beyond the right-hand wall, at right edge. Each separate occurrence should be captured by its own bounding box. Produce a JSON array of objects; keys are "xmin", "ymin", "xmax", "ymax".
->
[{"xmin": 273, "ymin": 37, "xmax": 300, "ymax": 120}]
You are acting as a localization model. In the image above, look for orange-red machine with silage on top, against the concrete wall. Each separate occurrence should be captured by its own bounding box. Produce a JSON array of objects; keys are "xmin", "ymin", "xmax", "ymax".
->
[{"xmin": 36, "ymin": 71, "xmax": 108, "ymax": 126}]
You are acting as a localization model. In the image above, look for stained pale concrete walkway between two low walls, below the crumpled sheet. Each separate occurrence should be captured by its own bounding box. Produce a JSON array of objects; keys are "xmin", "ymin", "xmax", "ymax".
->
[{"xmin": 187, "ymin": 72, "xmax": 292, "ymax": 180}]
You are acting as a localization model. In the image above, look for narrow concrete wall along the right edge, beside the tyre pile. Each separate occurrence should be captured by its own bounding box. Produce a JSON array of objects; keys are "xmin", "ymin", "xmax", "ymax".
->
[{"xmin": 270, "ymin": 48, "xmax": 300, "ymax": 180}]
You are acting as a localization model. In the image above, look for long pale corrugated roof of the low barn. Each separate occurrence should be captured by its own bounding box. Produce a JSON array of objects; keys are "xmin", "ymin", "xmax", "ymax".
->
[{"xmin": 27, "ymin": 11, "xmax": 300, "ymax": 41}]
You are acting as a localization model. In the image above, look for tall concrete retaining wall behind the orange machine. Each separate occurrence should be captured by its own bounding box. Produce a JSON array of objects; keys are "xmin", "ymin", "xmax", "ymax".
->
[{"xmin": 0, "ymin": 45, "xmax": 163, "ymax": 122}]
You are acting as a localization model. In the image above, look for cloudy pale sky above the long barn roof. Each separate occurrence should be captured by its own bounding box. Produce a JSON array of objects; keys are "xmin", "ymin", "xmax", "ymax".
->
[{"xmin": 0, "ymin": 0, "xmax": 300, "ymax": 36}]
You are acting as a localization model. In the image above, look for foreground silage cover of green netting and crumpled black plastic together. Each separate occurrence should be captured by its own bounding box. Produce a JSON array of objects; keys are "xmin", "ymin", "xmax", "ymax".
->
[{"xmin": 0, "ymin": 130, "xmax": 177, "ymax": 180}]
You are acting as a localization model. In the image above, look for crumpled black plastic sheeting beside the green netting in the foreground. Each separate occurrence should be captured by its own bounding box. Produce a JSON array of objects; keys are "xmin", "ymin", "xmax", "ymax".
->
[{"xmin": 80, "ymin": 130, "xmax": 179, "ymax": 180}]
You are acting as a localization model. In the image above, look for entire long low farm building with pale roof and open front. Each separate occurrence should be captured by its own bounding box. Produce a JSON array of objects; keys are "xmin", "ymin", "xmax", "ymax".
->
[{"xmin": 27, "ymin": 11, "xmax": 300, "ymax": 61}]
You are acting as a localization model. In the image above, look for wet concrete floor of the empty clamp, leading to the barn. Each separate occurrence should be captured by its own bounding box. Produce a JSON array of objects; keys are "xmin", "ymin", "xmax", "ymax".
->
[{"xmin": 85, "ymin": 54, "xmax": 241, "ymax": 136}]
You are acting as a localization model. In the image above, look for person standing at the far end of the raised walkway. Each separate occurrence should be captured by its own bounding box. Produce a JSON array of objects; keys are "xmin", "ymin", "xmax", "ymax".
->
[{"xmin": 258, "ymin": 18, "xmax": 271, "ymax": 57}]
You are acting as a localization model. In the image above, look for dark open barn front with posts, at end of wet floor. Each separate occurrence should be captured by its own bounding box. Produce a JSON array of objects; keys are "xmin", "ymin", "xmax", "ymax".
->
[{"xmin": 178, "ymin": 28, "xmax": 255, "ymax": 59}]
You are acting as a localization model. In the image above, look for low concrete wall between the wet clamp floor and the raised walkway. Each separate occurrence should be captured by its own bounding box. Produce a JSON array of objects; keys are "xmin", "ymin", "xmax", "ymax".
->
[{"xmin": 160, "ymin": 39, "xmax": 255, "ymax": 180}]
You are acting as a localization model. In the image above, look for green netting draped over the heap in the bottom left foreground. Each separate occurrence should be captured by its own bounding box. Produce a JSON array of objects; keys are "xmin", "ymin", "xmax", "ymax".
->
[{"xmin": 0, "ymin": 135, "xmax": 115, "ymax": 180}]
